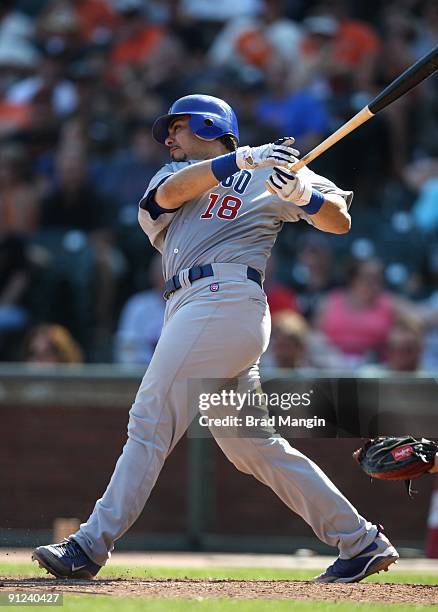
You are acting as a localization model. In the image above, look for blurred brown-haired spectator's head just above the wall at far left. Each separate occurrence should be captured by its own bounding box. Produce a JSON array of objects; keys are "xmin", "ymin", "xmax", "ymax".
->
[{"xmin": 23, "ymin": 324, "xmax": 83, "ymax": 365}]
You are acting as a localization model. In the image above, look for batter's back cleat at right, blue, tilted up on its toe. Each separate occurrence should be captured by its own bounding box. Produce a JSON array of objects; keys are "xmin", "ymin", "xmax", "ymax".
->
[{"xmin": 313, "ymin": 532, "xmax": 399, "ymax": 582}]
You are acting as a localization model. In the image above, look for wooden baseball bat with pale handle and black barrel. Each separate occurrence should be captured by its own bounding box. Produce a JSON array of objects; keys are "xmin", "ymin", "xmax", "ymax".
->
[{"xmin": 266, "ymin": 45, "xmax": 438, "ymax": 193}]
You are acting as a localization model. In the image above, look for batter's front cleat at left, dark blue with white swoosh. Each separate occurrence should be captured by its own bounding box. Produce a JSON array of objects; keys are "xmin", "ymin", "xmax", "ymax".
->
[{"xmin": 32, "ymin": 539, "xmax": 101, "ymax": 580}]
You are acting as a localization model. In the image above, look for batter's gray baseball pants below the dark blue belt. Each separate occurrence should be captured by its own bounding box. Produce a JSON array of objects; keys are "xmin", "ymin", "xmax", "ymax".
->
[{"xmin": 72, "ymin": 264, "xmax": 377, "ymax": 565}]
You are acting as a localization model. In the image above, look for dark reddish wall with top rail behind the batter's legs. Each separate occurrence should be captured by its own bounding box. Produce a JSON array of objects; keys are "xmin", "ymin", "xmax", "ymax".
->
[{"xmin": 0, "ymin": 364, "xmax": 438, "ymax": 552}]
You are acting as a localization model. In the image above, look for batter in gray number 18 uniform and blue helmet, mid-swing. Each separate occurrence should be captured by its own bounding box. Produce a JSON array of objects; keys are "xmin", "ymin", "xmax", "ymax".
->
[{"xmin": 32, "ymin": 95, "xmax": 398, "ymax": 582}]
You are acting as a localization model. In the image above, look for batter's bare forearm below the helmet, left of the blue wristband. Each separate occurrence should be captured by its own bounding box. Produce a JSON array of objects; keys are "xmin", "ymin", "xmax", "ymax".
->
[{"xmin": 155, "ymin": 160, "xmax": 222, "ymax": 209}]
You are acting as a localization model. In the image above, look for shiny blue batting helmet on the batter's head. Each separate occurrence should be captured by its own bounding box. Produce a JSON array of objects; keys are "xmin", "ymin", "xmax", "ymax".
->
[{"xmin": 152, "ymin": 94, "xmax": 239, "ymax": 144}]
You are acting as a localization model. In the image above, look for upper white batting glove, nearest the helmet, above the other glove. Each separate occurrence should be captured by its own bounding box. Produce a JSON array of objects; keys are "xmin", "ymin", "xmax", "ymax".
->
[{"xmin": 236, "ymin": 136, "xmax": 300, "ymax": 170}]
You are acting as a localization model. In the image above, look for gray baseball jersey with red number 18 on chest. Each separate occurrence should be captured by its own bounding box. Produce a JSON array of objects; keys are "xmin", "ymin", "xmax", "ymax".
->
[{"xmin": 139, "ymin": 162, "xmax": 353, "ymax": 279}]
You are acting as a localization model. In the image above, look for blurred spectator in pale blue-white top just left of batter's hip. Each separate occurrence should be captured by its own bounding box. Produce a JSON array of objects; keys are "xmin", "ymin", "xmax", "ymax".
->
[{"xmin": 115, "ymin": 254, "xmax": 165, "ymax": 365}]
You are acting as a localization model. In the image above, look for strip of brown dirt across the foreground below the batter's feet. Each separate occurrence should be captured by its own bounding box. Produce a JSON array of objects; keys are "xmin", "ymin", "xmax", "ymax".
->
[{"xmin": 0, "ymin": 576, "xmax": 438, "ymax": 605}]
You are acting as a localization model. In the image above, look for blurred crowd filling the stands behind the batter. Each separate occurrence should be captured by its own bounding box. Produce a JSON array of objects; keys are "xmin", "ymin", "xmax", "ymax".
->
[{"xmin": 0, "ymin": 0, "xmax": 438, "ymax": 372}]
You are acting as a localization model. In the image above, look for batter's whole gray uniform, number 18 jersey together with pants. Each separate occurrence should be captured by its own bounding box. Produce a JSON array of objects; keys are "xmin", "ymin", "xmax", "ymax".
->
[{"xmin": 72, "ymin": 162, "xmax": 377, "ymax": 565}]
